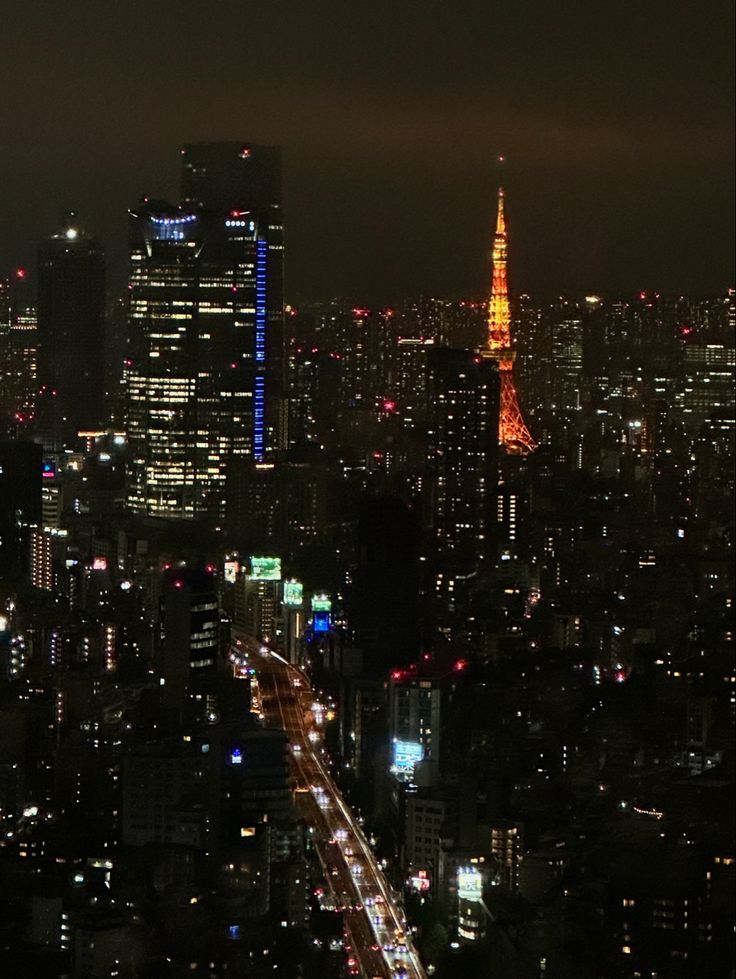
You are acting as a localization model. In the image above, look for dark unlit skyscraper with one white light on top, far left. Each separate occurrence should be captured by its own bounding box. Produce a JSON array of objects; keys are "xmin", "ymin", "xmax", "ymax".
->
[{"xmin": 37, "ymin": 212, "xmax": 105, "ymax": 450}]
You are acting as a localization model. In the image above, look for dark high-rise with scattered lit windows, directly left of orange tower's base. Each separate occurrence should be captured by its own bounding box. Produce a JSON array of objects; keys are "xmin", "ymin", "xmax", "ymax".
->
[{"xmin": 429, "ymin": 349, "xmax": 499, "ymax": 573}]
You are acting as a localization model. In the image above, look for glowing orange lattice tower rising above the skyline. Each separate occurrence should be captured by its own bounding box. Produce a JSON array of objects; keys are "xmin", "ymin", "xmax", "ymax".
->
[{"xmin": 481, "ymin": 187, "xmax": 537, "ymax": 455}]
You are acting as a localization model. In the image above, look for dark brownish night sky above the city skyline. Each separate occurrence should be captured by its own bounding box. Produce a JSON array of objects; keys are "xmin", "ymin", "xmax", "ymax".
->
[{"xmin": 0, "ymin": 0, "xmax": 734, "ymax": 302}]
